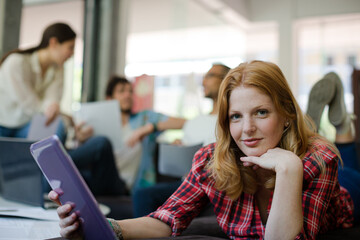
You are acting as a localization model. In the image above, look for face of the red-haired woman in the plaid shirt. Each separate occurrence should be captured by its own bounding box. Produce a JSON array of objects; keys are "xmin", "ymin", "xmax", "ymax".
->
[{"xmin": 228, "ymin": 86, "xmax": 285, "ymax": 156}]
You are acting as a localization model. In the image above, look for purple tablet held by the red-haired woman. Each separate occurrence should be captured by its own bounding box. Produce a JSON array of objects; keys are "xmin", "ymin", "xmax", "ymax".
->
[{"xmin": 30, "ymin": 135, "xmax": 116, "ymax": 239}]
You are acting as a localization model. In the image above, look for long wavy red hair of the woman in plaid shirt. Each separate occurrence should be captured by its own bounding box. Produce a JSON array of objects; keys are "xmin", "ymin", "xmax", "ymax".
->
[{"xmin": 207, "ymin": 61, "xmax": 336, "ymax": 199}]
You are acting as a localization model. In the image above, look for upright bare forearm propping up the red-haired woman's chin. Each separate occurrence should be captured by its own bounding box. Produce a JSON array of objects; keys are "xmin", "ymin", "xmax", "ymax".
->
[{"xmin": 265, "ymin": 162, "xmax": 303, "ymax": 240}]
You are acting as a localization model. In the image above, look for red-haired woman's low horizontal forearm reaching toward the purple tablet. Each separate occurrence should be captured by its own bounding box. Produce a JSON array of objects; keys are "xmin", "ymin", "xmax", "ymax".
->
[{"xmin": 118, "ymin": 217, "xmax": 171, "ymax": 239}]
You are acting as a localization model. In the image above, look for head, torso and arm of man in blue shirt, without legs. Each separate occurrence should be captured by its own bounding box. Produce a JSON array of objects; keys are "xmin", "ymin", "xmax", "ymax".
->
[{"xmin": 106, "ymin": 76, "xmax": 186, "ymax": 190}]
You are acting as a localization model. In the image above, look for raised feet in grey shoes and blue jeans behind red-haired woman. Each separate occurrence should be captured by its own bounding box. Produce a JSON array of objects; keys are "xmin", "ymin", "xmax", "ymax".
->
[{"xmin": 307, "ymin": 72, "xmax": 360, "ymax": 222}]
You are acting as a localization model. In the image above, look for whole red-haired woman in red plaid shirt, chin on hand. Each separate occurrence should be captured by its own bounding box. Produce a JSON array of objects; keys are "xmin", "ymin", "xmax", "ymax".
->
[{"xmin": 49, "ymin": 61, "xmax": 353, "ymax": 239}]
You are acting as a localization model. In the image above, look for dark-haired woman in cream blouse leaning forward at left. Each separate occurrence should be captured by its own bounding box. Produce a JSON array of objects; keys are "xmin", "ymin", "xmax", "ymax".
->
[{"xmin": 0, "ymin": 23, "xmax": 76, "ymax": 138}]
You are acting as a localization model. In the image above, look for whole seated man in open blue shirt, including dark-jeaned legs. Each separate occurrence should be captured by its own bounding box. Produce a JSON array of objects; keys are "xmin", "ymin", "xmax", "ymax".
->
[{"xmin": 60, "ymin": 76, "xmax": 185, "ymax": 195}]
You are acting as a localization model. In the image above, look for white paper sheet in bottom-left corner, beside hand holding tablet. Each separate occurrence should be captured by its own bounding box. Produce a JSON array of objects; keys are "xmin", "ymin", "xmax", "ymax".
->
[{"xmin": 0, "ymin": 217, "xmax": 60, "ymax": 240}]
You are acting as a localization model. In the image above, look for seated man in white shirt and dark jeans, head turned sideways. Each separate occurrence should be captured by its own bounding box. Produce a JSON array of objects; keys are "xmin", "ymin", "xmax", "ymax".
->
[{"xmin": 133, "ymin": 64, "xmax": 230, "ymax": 217}]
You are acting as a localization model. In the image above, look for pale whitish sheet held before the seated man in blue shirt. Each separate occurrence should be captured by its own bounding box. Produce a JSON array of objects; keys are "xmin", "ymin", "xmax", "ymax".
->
[{"xmin": 74, "ymin": 100, "xmax": 122, "ymax": 150}]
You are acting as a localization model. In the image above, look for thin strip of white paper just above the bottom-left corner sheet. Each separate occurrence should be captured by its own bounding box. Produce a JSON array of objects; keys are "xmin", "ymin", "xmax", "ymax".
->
[{"xmin": 0, "ymin": 207, "xmax": 59, "ymax": 221}]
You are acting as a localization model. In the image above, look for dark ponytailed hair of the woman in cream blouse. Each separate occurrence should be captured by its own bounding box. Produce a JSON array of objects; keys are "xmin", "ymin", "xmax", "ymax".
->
[{"xmin": 0, "ymin": 23, "xmax": 76, "ymax": 66}]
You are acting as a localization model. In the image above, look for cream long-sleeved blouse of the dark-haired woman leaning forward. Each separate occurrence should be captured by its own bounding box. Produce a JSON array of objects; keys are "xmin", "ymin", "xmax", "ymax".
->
[{"xmin": 0, "ymin": 51, "xmax": 64, "ymax": 128}]
